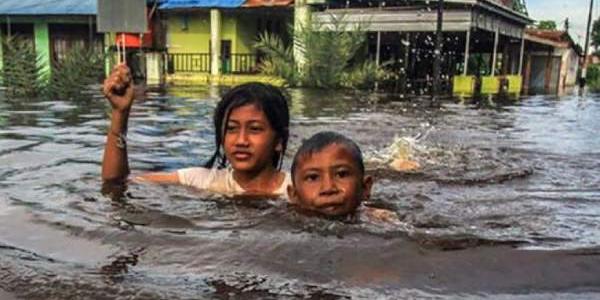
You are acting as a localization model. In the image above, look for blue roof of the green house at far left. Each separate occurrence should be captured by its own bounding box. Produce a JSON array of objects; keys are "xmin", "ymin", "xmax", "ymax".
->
[{"xmin": 0, "ymin": 0, "xmax": 97, "ymax": 15}]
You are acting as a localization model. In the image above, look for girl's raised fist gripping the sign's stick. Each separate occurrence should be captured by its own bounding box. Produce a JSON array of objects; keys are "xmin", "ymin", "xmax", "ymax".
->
[{"xmin": 102, "ymin": 64, "xmax": 134, "ymax": 112}]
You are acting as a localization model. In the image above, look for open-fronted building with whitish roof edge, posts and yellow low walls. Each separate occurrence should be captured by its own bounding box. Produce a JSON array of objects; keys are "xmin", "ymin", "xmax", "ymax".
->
[{"xmin": 312, "ymin": 0, "xmax": 532, "ymax": 94}]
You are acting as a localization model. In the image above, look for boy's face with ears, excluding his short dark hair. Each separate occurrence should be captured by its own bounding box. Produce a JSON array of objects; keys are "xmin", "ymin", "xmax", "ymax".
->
[{"xmin": 288, "ymin": 144, "xmax": 373, "ymax": 216}]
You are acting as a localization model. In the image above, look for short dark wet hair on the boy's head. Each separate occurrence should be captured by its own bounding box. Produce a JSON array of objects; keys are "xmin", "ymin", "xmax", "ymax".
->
[{"xmin": 291, "ymin": 131, "xmax": 365, "ymax": 178}]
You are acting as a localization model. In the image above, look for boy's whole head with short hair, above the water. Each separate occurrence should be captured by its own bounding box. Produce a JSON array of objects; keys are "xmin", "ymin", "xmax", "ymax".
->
[{"xmin": 288, "ymin": 132, "xmax": 373, "ymax": 216}]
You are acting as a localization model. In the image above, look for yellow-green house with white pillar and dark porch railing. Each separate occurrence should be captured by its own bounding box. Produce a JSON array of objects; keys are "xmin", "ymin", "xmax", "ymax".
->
[{"xmin": 159, "ymin": 0, "xmax": 293, "ymax": 81}]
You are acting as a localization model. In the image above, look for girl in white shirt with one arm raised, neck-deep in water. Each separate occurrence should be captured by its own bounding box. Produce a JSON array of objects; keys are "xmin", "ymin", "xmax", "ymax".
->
[{"xmin": 102, "ymin": 65, "xmax": 291, "ymax": 197}]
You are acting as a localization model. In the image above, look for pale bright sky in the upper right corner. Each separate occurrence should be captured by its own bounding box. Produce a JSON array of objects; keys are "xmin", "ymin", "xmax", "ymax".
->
[{"xmin": 525, "ymin": 0, "xmax": 600, "ymax": 46}]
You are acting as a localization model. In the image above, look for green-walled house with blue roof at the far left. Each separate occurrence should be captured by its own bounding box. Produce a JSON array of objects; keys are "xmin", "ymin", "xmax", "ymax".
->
[{"xmin": 0, "ymin": 0, "xmax": 104, "ymax": 78}]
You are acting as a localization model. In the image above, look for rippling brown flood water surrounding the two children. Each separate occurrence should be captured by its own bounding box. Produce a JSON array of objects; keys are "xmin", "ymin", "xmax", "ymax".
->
[{"xmin": 0, "ymin": 88, "xmax": 600, "ymax": 299}]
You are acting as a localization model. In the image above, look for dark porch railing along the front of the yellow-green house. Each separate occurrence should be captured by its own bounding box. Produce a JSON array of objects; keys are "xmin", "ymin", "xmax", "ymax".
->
[{"xmin": 167, "ymin": 53, "xmax": 258, "ymax": 74}]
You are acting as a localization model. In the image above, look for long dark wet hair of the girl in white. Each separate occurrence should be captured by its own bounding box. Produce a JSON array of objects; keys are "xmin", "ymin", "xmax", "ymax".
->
[{"xmin": 204, "ymin": 82, "xmax": 290, "ymax": 169}]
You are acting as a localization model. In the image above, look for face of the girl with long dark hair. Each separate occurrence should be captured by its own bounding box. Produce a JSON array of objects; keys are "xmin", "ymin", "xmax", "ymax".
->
[{"xmin": 223, "ymin": 104, "xmax": 282, "ymax": 172}]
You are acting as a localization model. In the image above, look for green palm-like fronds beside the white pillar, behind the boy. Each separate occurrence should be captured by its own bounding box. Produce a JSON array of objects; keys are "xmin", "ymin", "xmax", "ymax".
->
[{"xmin": 255, "ymin": 17, "xmax": 384, "ymax": 88}]
